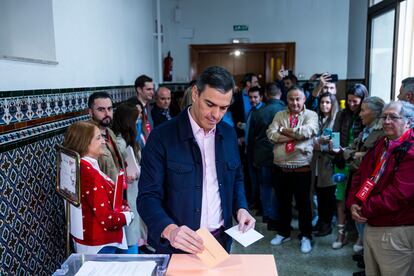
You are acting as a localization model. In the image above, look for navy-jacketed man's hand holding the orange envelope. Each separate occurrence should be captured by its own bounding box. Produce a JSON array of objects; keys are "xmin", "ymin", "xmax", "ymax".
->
[{"xmin": 162, "ymin": 224, "xmax": 204, "ymax": 254}]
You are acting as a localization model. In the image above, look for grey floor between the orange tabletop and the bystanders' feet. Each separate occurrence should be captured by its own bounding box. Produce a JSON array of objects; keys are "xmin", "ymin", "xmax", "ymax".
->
[{"xmin": 231, "ymin": 217, "xmax": 361, "ymax": 276}]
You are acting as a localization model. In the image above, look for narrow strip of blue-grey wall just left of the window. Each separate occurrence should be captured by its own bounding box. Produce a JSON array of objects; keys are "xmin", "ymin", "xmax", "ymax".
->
[{"xmin": 347, "ymin": 0, "xmax": 368, "ymax": 79}]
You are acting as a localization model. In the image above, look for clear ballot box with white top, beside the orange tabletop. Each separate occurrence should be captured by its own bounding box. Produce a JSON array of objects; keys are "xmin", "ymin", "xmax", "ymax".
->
[{"xmin": 53, "ymin": 254, "xmax": 170, "ymax": 276}]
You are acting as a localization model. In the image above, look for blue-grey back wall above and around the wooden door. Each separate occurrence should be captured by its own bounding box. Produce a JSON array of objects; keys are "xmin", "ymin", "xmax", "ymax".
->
[{"xmin": 161, "ymin": 0, "xmax": 349, "ymax": 81}]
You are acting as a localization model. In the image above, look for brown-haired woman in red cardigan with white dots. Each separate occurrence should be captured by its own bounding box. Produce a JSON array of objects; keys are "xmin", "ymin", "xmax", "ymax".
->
[{"xmin": 63, "ymin": 122, "xmax": 133, "ymax": 254}]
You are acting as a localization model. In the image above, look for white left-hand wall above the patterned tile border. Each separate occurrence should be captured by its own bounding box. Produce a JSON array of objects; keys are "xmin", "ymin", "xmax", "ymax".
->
[{"xmin": 0, "ymin": 0, "xmax": 155, "ymax": 91}]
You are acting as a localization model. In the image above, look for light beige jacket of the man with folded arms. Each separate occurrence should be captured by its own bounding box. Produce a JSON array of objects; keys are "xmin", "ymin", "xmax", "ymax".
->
[{"xmin": 266, "ymin": 107, "xmax": 319, "ymax": 168}]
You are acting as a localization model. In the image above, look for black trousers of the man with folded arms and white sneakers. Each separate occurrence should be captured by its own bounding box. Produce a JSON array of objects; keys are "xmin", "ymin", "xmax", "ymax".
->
[{"xmin": 276, "ymin": 171, "xmax": 312, "ymax": 239}]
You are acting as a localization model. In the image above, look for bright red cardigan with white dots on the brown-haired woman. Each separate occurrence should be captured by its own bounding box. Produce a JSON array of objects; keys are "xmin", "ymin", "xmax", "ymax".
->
[{"xmin": 74, "ymin": 159, "xmax": 126, "ymax": 246}]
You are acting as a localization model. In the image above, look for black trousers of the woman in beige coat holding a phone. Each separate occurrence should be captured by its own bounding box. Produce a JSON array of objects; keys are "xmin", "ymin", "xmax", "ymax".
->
[{"xmin": 315, "ymin": 185, "xmax": 336, "ymax": 224}]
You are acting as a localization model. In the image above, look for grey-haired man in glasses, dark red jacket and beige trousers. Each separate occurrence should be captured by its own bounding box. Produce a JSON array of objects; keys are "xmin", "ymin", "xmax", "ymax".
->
[{"xmin": 347, "ymin": 101, "xmax": 414, "ymax": 275}]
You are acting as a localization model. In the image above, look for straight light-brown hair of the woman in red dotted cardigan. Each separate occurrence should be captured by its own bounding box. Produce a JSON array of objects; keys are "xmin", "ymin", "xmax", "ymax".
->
[{"xmin": 63, "ymin": 121, "xmax": 98, "ymax": 157}]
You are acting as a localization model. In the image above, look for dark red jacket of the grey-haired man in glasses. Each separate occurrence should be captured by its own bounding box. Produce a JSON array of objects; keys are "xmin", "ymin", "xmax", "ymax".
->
[{"xmin": 346, "ymin": 130, "xmax": 414, "ymax": 227}]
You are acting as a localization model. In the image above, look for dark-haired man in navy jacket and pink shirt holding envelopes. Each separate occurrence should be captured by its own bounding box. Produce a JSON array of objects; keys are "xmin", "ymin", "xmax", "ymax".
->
[{"xmin": 137, "ymin": 66, "xmax": 255, "ymax": 254}]
